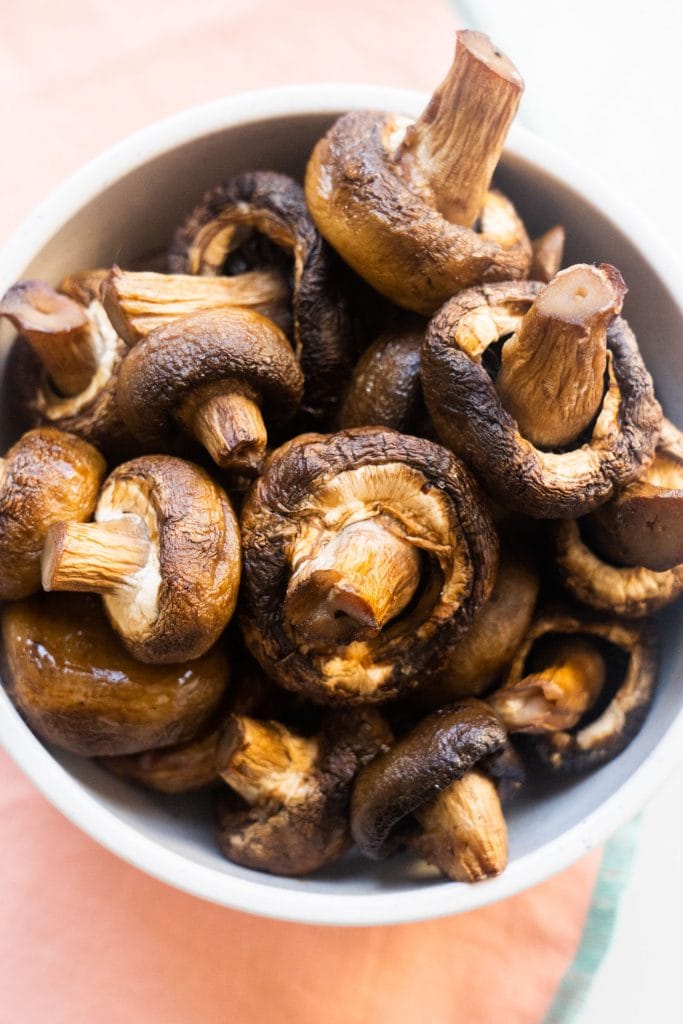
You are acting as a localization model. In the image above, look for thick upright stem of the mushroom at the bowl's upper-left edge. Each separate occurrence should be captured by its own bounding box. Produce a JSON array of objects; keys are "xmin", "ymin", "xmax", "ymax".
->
[{"xmin": 0, "ymin": 281, "xmax": 98, "ymax": 396}]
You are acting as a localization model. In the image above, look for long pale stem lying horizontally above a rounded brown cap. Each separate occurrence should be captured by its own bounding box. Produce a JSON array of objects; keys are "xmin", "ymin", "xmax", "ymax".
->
[{"xmin": 101, "ymin": 266, "xmax": 292, "ymax": 345}]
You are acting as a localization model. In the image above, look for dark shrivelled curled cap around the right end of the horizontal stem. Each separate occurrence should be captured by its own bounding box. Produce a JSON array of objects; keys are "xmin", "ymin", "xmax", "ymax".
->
[{"xmin": 168, "ymin": 171, "xmax": 354, "ymax": 418}]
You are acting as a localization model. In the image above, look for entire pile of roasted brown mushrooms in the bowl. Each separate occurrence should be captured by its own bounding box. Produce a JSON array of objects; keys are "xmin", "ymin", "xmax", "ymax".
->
[{"xmin": 0, "ymin": 32, "xmax": 683, "ymax": 882}]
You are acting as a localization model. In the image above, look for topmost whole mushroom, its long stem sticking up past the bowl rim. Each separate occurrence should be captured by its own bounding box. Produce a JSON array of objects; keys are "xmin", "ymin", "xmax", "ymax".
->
[{"xmin": 306, "ymin": 32, "xmax": 531, "ymax": 315}]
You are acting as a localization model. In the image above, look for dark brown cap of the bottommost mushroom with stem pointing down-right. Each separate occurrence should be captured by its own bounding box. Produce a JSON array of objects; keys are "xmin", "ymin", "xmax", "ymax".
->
[{"xmin": 351, "ymin": 697, "xmax": 507, "ymax": 860}]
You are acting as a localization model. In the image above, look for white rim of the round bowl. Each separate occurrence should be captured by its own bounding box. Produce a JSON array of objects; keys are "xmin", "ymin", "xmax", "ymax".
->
[{"xmin": 0, "ymin": 83, "xmax": 683, "ymax": 926}]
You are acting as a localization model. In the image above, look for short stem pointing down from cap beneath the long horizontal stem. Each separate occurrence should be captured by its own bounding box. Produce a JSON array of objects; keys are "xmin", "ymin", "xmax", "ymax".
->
[{"xmin": 177, "ymin": 381, "xmax": 268, "ymax": 476}]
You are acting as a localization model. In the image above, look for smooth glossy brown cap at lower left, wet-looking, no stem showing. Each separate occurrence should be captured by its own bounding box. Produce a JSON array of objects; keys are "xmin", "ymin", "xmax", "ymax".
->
[{"xmin": 2, "ymin": 594, "xmax": 228, "ymax": 757}]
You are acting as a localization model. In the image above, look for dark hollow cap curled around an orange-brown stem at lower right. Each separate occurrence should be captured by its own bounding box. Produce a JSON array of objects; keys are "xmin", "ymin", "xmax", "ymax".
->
[{"xmin": 504, "ymin": 608, "xmax": 657, "ymax": 774}]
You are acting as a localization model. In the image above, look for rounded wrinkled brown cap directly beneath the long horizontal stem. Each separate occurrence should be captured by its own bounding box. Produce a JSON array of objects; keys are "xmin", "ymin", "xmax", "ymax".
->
[{"xmin": 117, "ymin": 308, "xmax": 303, "ymax": 444}]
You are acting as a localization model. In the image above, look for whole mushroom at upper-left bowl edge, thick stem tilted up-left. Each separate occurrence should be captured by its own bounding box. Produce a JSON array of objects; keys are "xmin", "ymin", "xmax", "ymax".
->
[{"xmin": 0, "ymin": 270, "xmax": 132, "ymax": 451}]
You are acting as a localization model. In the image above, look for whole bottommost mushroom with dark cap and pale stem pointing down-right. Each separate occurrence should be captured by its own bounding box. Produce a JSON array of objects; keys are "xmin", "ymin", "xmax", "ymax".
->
[{"xmin": 351, "ymin": 698, "xmax": 516, "ymax": 882}]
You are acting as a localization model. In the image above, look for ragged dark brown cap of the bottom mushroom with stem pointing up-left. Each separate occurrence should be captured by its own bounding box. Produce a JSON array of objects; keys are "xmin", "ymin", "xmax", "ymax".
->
[{"xmin": 216, "ymin": 709, "xmax": 390, "ymax": 876}]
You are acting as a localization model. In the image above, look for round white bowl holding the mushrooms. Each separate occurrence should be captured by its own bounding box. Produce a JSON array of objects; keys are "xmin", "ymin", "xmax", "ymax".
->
[{"xmin": 0, "ymin": 86, "xmax": 683, "ymax": 925}]
